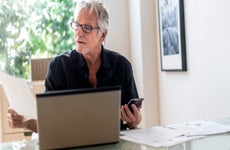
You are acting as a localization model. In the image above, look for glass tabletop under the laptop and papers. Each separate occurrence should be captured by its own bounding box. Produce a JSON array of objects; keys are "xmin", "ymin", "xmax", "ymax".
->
[{"xmin": 0, "ymin": 134, "xmax": 230, "ymax": 150}]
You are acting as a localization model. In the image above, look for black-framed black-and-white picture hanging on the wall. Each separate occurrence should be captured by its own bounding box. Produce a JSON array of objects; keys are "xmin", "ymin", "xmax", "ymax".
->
[{"xmin": 158, "ymin": 0, "xmax": 187, "ymax": 71}]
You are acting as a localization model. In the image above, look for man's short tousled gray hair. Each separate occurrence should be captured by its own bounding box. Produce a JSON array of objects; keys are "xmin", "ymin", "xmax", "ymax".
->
[{"xmin": 74, "ymin": 0, "xmax": 109, "ymax": 33}]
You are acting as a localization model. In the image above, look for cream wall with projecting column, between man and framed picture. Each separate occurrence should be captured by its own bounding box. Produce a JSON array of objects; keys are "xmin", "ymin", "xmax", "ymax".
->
[{"xmin": 104, "ymin": 0, "xmax": 159, "ymax": 126}]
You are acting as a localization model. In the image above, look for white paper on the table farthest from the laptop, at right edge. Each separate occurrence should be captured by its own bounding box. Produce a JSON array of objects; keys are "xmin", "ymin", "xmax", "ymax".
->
[{"xmin": 167, "ymin": 120, "xmax": 230, "ymax": 136}]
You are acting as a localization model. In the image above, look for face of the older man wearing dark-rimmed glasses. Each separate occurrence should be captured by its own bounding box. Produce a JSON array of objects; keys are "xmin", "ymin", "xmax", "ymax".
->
[{"xmin": 74, "ymin": 8, "xmax": 104, "ymax": 53}]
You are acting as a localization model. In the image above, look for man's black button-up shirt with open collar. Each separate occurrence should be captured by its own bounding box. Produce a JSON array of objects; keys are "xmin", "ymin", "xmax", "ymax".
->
[{"xmin": 45, "ymin": 46, "xmax": 138, "ymax": 129}]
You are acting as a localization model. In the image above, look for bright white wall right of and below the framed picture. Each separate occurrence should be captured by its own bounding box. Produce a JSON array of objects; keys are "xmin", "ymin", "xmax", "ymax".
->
[{"xmin": 159, "ymin": 0, "xmax": 230, "ymax": 124}]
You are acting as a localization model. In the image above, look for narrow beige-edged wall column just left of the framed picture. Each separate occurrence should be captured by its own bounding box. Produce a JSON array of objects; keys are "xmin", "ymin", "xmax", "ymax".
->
[{"xmin": 129, "ymin": 0, "xmax": 159, "ymax": 127}]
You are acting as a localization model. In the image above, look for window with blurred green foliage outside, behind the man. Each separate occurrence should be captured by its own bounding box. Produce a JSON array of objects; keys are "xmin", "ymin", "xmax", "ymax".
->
[{"xmin": 0, "ymin": 0, "xmax": 76, "ymax": 79}]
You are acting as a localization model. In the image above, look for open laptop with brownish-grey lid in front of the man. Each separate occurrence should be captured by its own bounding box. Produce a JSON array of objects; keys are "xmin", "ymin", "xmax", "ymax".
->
[{"xmin": 36, "ymin": 87, "xmax": 121, "ymax": 149}]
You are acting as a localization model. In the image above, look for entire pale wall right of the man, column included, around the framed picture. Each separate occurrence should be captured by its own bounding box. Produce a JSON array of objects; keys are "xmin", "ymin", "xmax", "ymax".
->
[{"xmin": 104, "ymin": 0, "xmax": 230, "ymax": 127}]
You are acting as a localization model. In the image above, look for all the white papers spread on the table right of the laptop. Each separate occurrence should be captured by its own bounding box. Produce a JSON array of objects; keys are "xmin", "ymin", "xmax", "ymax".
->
[{"xmin": 120, "ymin": 120, "xmax": 230, "ymax": 147}]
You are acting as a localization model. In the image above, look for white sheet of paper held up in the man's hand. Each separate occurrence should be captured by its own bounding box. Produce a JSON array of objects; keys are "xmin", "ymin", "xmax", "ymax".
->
[{"xmin": 0, "ymin": 72, "xmax": 37, "ymax": 119}]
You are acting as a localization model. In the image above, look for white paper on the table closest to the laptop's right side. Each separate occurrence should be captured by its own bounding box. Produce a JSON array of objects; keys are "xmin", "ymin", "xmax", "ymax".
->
[{"xmin": 120, "ymin": 126, "xmax": 200, "ymax": 147}]
